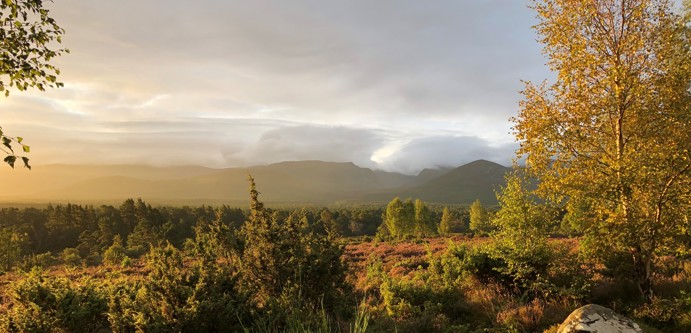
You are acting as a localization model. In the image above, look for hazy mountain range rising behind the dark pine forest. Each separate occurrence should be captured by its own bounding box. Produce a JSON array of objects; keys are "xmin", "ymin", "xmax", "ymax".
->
[{"xmin": 0, "ymin": 160, "xmax": 510, "ymax": 205}]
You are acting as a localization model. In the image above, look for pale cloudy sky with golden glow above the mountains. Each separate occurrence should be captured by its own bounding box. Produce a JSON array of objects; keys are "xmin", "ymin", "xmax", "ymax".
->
[{"xmin": 0, "ymin": 0, "xmax": 551, "ymax": 174}]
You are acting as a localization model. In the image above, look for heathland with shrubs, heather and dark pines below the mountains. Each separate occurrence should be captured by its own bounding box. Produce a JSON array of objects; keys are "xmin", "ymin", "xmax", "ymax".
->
[{"xmin": 0, "ymin": 178, "xmax": 691, "ymax": 332}]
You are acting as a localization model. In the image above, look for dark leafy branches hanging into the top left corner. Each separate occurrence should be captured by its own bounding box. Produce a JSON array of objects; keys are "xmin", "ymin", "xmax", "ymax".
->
[{"xmin": 0, "ymin": 0, "xmax": 69, "ymax": 169}]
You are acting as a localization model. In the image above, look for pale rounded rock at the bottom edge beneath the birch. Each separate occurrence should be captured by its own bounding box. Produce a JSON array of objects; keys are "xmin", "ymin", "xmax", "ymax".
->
[{"xmin": 557, "ymin": 304, "xmax": 643, "ymax": 333}]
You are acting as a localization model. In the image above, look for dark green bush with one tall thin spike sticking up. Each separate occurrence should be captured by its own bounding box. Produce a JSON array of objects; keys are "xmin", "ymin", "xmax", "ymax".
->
[{"xmin": 239, "ymin": 177, "xmax": 350, "ymax": 325}]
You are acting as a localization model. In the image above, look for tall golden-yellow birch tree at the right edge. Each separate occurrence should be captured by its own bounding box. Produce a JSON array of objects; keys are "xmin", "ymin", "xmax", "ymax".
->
[{"xmin": 512, "ymin": 0, "xmax": 691, "ymax": 300}]
